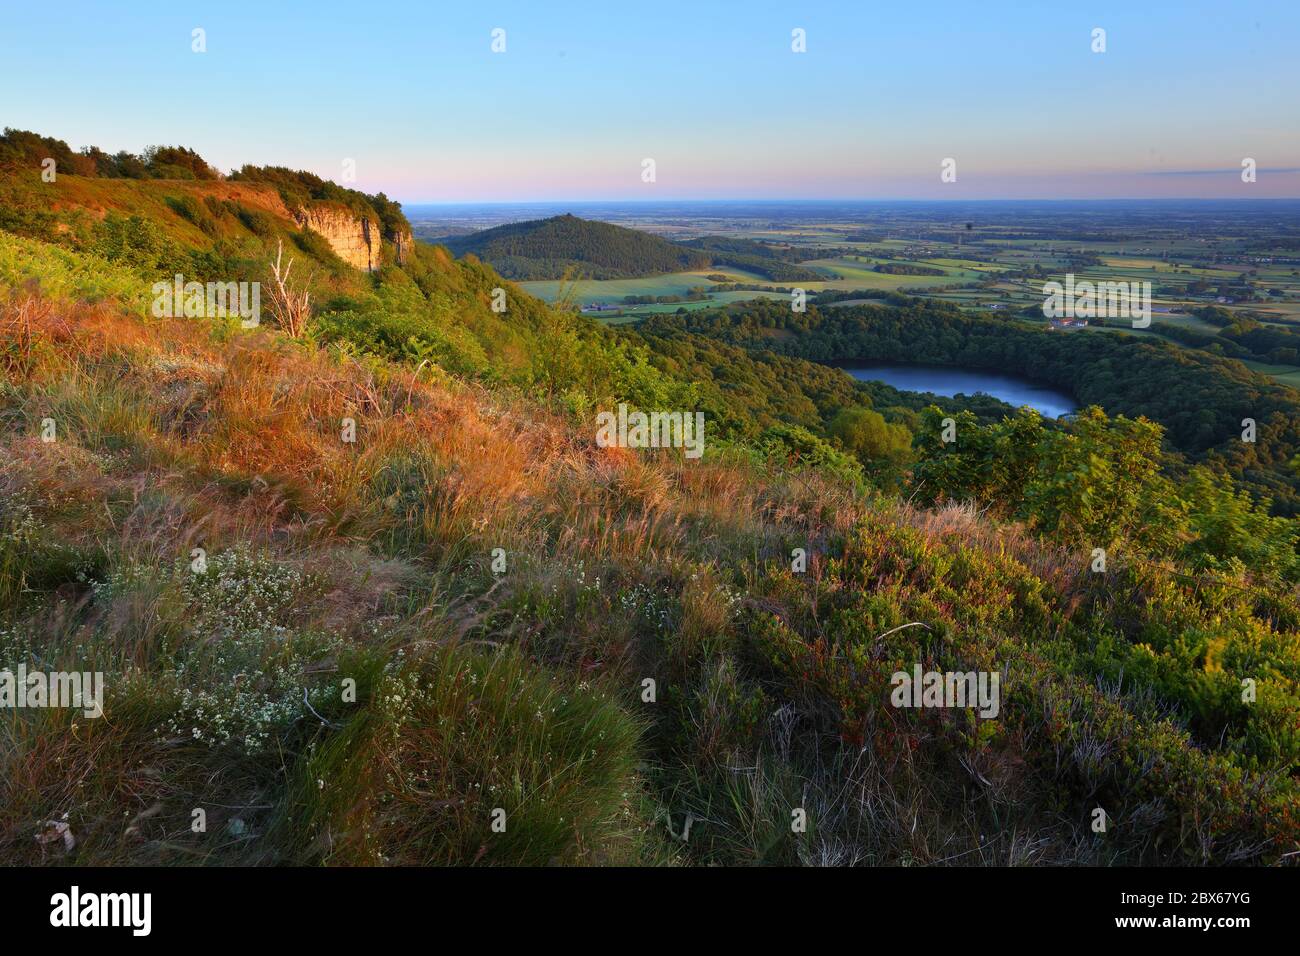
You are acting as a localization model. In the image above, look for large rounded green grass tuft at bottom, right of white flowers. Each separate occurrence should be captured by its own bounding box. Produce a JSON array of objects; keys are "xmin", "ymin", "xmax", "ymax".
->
[{"xmin": 287, "ymin": 648, "xmax": 650, "ymax": 866}]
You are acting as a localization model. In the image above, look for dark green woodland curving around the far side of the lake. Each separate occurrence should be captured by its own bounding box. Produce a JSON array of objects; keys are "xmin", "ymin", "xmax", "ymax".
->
[{"xmin": 655, "ymin": 299, "xmax": 1300, "ymax": 514}]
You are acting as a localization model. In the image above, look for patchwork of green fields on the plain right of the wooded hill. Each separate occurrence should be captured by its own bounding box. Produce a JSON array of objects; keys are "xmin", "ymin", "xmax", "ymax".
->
[{"xmin": 504, "ymin": 209, "xmax": 1300, "ymax": 386}]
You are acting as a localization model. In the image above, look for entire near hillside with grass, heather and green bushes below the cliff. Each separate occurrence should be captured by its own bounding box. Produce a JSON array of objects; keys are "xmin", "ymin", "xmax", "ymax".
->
[{"xmin": 0, "ymin": 157, "xmax": 1300, "ymax": 865}]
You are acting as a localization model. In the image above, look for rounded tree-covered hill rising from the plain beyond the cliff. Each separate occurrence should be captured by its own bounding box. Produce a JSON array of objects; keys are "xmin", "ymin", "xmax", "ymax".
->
[{"xmin": 446, "ymin": 215, "xmax": 712, "ymax": 280}]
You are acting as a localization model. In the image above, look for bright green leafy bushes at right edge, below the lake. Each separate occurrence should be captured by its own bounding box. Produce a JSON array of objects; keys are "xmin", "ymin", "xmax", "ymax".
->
[{"xmin": 913, "ymin": 407, "xmax": 1300, "ymax": 585}]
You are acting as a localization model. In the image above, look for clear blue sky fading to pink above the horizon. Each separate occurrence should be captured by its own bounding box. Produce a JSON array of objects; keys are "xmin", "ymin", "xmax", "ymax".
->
[{"xmin": 0, "ymin": 0, "xmax": 1300, "ymax": 203}]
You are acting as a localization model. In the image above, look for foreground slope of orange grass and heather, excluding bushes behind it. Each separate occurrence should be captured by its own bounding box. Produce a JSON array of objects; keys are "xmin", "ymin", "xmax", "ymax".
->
[{"xmin": 0, "ymin": 223, "xmax": 1297, "ymax": 864}]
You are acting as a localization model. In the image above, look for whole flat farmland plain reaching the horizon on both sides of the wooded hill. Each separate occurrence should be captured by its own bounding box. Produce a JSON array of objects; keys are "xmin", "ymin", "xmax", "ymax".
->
[{"xmin": 412, "ymin": 200, "xmax": 1300, "ymax": 385}]
